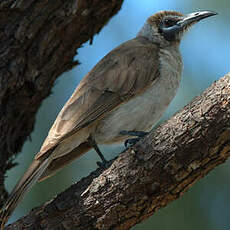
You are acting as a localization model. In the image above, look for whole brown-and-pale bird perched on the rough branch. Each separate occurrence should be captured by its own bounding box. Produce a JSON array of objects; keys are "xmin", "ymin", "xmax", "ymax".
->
[{"xmin": 1, "ymin": 11, "xmax": 217, "ymax": 229}]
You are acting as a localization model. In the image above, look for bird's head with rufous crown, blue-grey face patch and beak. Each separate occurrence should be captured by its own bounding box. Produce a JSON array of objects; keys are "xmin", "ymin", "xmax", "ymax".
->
[{"xmin": 139, "ymin": 11, "xmax": 217, "ymax": 45}]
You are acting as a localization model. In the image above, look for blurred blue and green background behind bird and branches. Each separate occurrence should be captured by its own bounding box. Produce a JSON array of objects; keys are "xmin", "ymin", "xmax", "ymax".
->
[{"xmin": 6, "ymin": 0, "xmax": 230, "ymax": 230}]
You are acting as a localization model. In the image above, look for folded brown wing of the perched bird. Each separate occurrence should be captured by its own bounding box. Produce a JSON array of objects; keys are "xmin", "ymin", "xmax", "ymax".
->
[{"xmin": 36, "ymin": 37, "xmax": 159, "ymax": 159}]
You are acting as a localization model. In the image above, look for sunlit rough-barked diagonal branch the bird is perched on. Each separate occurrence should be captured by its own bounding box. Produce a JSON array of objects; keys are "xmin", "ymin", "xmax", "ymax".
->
[{"xmin": 4, "ymin": 74, "xmax": 230, "ymax": 230}]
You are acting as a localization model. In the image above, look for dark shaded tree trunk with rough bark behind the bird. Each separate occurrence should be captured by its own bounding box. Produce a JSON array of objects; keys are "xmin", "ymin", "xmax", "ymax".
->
[{"xmin": 0, "ymin": 0, "xmax": 123, "ymax": 204}]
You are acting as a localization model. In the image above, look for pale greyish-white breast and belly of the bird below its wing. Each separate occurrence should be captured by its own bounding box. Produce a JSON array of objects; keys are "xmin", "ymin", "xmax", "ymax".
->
[{"xmin": 94, "ymin": 45, "xmax": 182, "ymax": 144}]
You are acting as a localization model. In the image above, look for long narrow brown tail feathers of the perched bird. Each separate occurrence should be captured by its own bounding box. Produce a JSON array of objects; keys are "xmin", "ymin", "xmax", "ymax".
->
[{"xmin": 0, "ymin": 157, "xmax": 51, "ymax": 230}]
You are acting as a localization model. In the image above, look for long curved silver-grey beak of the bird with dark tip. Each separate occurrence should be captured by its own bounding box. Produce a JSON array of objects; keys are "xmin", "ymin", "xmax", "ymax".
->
[{"xmin": 177, "ymin": 11, "xmax": 217, "ymax": 29}]
